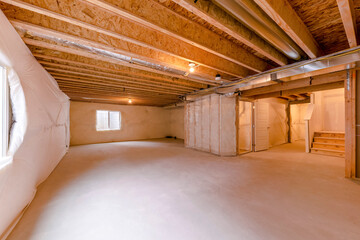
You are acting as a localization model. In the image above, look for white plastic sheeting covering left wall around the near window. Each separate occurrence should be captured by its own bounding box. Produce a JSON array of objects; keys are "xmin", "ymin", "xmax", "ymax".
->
[{"xmin": 0, "ymin": 11, "xmax": 69, "ymax": 237}]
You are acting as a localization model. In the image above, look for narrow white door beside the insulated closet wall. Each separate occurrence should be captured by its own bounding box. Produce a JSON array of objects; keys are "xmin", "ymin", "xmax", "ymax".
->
[{"xmin": 254, "ymin": 101, "xmax": 269, "ymax": 151}]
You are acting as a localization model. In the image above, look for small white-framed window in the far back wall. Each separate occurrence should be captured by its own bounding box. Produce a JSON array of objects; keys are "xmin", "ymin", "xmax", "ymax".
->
[{"xmin": 96, "ymin": 110, "xmax": 121, "ymax": 131}]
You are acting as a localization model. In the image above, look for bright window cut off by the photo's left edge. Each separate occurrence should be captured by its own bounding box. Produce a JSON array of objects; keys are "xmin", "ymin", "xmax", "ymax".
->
[{"xmin": 0, "ymin": 66, "xmax": 10, "ymax": 159}]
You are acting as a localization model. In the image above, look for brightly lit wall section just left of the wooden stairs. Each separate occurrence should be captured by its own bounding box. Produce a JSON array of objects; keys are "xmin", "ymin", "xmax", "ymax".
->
[{"xmin": 290, "ymin": 103, "xmax": 309, "ymax": 141}]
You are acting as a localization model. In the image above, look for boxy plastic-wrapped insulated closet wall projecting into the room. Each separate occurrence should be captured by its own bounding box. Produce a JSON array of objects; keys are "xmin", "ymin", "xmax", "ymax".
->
[{"xmin": 184, "ymin": 94, "xmax": 236, "ymax": 156}]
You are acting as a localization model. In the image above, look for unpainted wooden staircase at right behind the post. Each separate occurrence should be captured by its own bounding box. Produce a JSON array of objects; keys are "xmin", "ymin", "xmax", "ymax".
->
[{"xmin": 311, "ymin": 131, "xmax": 345, "ymax": 157}]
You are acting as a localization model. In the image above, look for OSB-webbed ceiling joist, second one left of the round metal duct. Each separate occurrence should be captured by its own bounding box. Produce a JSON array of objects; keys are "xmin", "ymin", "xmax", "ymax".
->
[{"xmin": 85, "ymin": 0, "xmax": 269, "ymax": 72}]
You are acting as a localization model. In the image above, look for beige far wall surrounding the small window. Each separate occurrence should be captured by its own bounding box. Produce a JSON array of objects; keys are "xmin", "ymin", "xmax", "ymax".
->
[{"xmin": 70, "ymin": 101, "xmax": 170, "ymax": 145}]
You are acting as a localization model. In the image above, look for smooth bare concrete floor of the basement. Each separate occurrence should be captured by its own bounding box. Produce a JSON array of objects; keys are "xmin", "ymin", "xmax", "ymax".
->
[{"xmin": 8, "ymin": 140, "xmax": 360, "ymax": 240}]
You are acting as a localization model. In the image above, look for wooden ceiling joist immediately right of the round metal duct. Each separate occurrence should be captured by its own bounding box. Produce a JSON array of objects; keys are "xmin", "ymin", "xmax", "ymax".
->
[{"xmin": 254, "ymin": 0, "xmax": 322, "ymax": 58}]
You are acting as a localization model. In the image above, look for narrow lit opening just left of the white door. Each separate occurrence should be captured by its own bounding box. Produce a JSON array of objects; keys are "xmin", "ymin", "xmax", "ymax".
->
[{"xmin": 238, "ymin": 101, "xmax": 252, "ymax": 151}]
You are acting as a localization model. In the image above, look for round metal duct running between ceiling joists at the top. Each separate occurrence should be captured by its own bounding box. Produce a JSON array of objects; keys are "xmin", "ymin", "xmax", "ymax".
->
[{"xmin": 216, "ymin": 0, "xmax": 302, "ymax": 60}]
